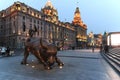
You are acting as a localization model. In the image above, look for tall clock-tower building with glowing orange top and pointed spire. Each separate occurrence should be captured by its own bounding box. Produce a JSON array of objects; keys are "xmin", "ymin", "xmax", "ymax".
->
[{"xmin": 72, "ymin": 7, "xmax": 87, "ymax": 48}]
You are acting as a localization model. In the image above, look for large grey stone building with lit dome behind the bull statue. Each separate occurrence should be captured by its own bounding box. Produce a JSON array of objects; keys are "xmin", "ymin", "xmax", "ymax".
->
[{"xmin": 0, "ymin": 1, "xmax": 86, "ymax": 48}]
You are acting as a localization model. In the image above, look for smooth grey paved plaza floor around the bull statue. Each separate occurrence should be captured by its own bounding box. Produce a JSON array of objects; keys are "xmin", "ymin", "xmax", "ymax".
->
[{"xmin": 0, "ymin": 50, "xmax": 120, "ymax": 80}]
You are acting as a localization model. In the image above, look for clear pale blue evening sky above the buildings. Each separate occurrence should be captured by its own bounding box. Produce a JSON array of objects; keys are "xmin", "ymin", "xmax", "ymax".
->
[{"xmin": 0, "ymin": 0, "xmax": 120, "ymax": 34}]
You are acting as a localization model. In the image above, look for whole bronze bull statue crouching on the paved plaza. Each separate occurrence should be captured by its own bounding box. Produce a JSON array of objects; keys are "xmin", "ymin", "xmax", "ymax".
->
[{"xmin": 21, "ymin": 38, "xmax": 64, "ymax": 69}]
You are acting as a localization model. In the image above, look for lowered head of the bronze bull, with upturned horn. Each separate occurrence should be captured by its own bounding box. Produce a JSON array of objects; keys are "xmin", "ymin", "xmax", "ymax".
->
[{"xmin": 40, "ymin": 39, "xmax": 61, "ymax": 66}]
